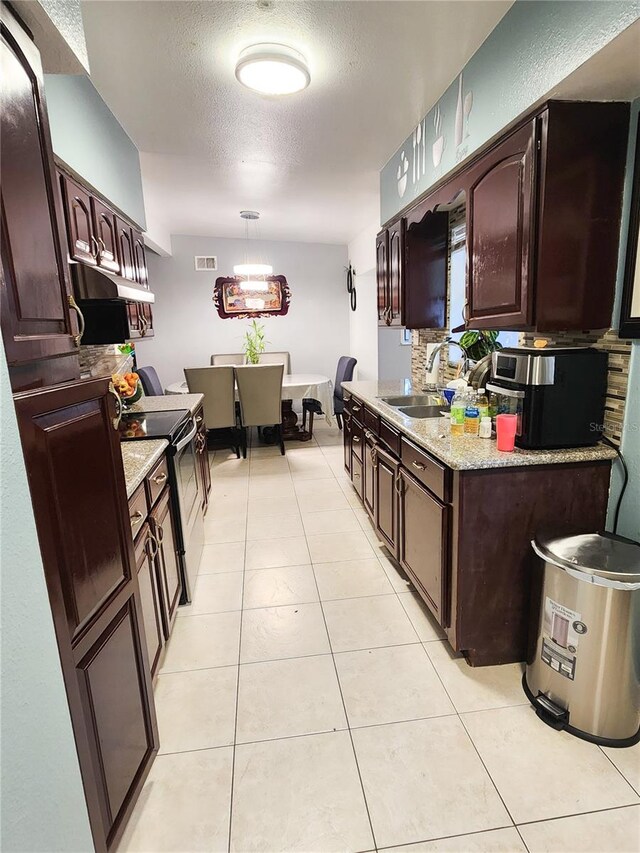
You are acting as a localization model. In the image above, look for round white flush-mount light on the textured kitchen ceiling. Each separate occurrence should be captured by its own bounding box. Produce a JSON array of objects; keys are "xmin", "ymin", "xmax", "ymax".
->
[{"xmin": 236, "ymin": 44, "xmax": 311, "ymax": 95}]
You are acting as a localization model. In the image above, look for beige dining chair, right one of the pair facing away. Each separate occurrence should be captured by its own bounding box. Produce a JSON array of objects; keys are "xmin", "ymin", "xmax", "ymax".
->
[{"xmin": 235, "ymin": 364, "xmax": 284, "ymax": 459}]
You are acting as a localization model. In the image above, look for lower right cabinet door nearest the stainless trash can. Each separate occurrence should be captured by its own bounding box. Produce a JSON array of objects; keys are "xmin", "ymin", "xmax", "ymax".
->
[{"xmin": 399, "ymin": 468, "xmax": 449, "ymax": 628}]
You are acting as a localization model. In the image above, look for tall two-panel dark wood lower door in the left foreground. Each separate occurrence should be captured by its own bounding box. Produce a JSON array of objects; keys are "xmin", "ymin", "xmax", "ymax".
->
[{"xmin": 14, "ymin": 379, "xmax": 158, "ymax": 851}]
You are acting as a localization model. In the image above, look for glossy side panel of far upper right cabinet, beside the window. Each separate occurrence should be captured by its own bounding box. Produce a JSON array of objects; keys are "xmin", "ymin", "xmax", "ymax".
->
[{"xmin": 402, "ymin": 210, "xmax": 449, "ymax": 329}]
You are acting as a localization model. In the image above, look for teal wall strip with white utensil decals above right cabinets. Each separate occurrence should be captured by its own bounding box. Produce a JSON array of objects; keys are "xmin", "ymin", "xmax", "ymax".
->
[{"xmin": 380, "ymin": 0, "xmax": 640, "ymax": 222}]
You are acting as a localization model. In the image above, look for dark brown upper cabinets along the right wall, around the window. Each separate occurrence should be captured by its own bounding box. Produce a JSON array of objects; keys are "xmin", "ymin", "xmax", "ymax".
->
[{"xmin": 376, "ymin": 101, "xmax": 629, "ymax": 332}]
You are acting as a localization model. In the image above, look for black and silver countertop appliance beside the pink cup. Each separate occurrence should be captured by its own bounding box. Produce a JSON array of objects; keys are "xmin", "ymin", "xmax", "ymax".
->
[{"xmin": 487, "ymin": 346, "xmax": 608, "ymax": 450}]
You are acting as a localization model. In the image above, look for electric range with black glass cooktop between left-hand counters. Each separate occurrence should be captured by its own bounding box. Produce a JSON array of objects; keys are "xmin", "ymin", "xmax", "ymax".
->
[{"xmin": 119, "ymin": 409, "xmax": 204, "ymax": 604}]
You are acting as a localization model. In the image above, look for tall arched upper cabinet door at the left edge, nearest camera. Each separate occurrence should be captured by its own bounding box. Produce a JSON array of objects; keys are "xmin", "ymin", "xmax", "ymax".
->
[{"xmin": 0, "ymin": 4, "xmax": 80, "ymax": 376}]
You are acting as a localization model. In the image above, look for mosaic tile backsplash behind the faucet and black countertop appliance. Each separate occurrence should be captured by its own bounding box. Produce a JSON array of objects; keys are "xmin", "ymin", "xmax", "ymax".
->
[{"xmin": 411, "ymin": 329, "xmax": 631, "ymax": 444}]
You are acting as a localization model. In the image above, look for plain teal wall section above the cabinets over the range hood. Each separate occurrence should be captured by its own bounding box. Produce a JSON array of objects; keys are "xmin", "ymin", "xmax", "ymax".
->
[{"xmin": 44, "ymin": 74, "xmax": 146, "ymax": 230}]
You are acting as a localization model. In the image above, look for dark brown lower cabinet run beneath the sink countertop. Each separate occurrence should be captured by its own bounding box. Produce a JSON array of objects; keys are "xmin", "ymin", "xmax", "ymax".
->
[{"xmin": 344, "ymin": 395, "xmax": 611, "ymax": 666}]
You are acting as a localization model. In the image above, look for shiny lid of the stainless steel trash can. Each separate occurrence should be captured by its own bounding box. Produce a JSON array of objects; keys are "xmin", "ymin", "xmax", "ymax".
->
[{"xmin": 532, "ymin": 533, "xmax": 640, "ymax": 583}]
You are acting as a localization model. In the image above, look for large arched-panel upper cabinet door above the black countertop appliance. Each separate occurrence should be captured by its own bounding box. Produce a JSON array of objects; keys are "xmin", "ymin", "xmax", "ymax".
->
[{"xmin": 466, "ymin": 121, "xmax": 536, "ymax": 329}]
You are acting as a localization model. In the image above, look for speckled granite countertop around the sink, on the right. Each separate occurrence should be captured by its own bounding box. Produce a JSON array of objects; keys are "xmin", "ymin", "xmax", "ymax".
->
[{"xmin": 342, "ymin": 379, "xmax": 616, "ymax": 470}]
